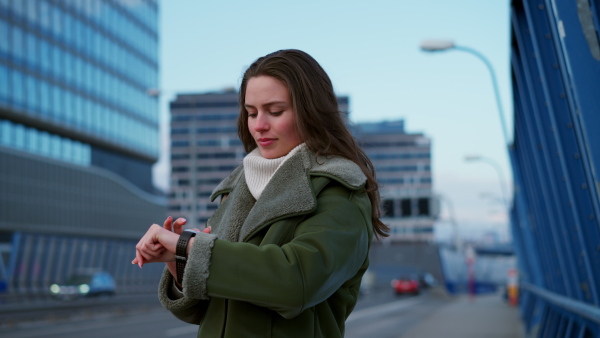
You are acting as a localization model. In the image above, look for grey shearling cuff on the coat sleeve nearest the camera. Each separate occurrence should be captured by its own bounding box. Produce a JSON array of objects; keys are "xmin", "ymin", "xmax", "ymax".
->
[{"xmin": 182, "ymin": 232, "xmax": 217, "ymax": 299}]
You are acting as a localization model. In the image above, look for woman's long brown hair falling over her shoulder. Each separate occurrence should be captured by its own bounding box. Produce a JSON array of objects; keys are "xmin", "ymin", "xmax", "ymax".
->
[{"xmin": 238, "ymin": 49, "xmax": 390, "ymax": 238}]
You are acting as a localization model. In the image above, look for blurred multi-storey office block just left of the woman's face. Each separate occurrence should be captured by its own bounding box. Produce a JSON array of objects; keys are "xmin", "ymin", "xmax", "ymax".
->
[{"xmin": 168, "ymin": 90, "xmax": 246, "ymax": 228}]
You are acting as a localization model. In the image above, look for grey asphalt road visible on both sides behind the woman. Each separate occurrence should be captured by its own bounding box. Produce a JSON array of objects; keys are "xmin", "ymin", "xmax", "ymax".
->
[{"xmin": 0, "ymin": 289, "xmax": 445, "ymax": 338}]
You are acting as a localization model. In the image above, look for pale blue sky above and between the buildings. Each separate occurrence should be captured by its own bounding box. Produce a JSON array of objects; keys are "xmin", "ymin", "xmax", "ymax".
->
[{"xmin": 154, "ymin": 0, "xmax": 513, "ymax": 240}]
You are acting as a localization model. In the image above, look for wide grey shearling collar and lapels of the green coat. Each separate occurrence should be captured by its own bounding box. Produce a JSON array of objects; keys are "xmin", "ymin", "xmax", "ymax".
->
[{"xmin": 208, "ymin": 148, "xmax": 366, "ymax": 241}]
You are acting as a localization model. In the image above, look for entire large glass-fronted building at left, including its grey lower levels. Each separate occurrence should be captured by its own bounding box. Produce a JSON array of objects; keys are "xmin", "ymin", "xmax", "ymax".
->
[{"xmin": 0, "ymin": 0, "xmax": 166, "ymax": 294}]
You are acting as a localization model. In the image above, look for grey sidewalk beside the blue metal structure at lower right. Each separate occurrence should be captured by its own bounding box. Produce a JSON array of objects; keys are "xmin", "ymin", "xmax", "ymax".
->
[{"xmin": 399, "ymin": 294, "xmax": 525, "ymax": 338}]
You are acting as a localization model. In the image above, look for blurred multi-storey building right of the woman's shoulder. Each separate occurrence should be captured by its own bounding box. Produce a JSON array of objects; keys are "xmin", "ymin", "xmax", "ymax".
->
[{"xmin": 354, "ymin": 120, "xmax": 437, "ymax": 242}]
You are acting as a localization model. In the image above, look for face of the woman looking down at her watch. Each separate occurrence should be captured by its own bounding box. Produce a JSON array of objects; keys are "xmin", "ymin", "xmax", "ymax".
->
[{"xmin": 245, "ymin": 75, "xmax": 302, "ymax": 159}]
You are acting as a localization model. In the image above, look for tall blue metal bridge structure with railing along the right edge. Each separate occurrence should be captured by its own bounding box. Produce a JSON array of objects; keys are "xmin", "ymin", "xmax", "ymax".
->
[{"xmin": 510, "ymin": 0, "xmax": 600, "ymax": 337}]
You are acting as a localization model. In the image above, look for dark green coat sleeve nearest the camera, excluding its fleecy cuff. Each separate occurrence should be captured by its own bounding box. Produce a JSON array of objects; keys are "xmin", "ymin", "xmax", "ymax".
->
[{"xmin": 196, "ymin": 185, "xmax": 372, "ymax": 318}]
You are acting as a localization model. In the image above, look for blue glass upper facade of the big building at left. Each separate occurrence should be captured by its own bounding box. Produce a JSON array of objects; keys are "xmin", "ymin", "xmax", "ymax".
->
[{"xmin": 0, "ymin": 0, "xmax": 158, "ymax": 182}]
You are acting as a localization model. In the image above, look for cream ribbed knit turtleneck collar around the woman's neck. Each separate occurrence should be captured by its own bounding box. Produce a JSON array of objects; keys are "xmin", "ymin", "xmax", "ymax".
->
[{"xmin": 244, "ymin": 143, "xmax": 306, "ymax": 200}]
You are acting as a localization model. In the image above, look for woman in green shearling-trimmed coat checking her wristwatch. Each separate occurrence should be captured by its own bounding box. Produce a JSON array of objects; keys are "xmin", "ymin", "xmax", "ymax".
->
[{"xmin": 133, "ymin": 50, "xmax": 389, "ymax": 337}]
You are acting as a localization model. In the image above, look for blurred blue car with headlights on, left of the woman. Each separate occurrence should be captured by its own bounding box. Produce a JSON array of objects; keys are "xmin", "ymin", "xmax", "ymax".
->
[{"xmin": 50, "ymin": 271, "xmax": 116, "ymax": 299}]
